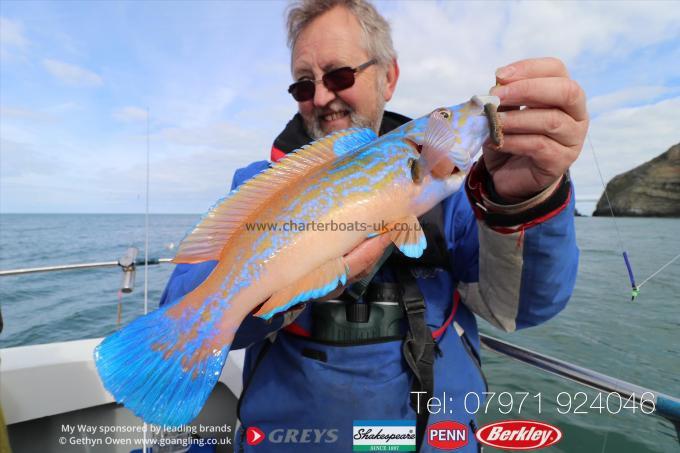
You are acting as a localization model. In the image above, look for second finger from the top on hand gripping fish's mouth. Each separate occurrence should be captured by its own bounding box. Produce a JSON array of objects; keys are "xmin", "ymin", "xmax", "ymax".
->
[{"xmin": 491, "ymin": 77, "xmax": 588, "ymax": 121}]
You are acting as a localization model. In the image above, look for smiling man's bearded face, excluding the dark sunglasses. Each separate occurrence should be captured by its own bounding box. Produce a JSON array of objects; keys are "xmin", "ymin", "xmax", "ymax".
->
[{"xmin": 292, "ymin": 7, "xmax": 391, "ymax": 139}]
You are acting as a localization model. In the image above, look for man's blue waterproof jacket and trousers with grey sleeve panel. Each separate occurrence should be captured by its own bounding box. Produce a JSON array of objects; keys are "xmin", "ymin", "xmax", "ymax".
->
[{"xmin": 161, "ymin": 114, "xmax": 578, "ymax": 452}]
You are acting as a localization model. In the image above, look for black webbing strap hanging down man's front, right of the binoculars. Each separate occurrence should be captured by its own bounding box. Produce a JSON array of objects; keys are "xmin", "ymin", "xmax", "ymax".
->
[{"xmin": 395, "ymin": 266, "xmax": 435, "ymax": 451}]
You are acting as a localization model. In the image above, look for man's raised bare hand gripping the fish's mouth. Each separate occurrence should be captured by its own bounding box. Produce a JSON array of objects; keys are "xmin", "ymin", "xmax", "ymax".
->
[{"xmin": 483, "ymin": 58, "xmax": 588, "ymax": 203}]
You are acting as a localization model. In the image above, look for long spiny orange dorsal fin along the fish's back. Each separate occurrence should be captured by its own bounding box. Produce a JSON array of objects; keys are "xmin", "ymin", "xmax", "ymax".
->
[{"xmin": 173, "ymin": 128, "xmax": 377, "ymax": 263}]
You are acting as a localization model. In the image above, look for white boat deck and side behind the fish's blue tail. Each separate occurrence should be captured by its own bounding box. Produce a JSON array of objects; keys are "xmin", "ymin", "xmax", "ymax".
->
[{"xmin": 0, "ymin": 338, "xmax": 244, "ymax": 453}]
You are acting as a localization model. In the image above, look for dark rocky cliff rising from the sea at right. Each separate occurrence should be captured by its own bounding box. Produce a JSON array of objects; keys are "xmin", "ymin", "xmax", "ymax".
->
[{"xmin": 593, "ymin": 143, "xmax": 680, "ymax": 217}]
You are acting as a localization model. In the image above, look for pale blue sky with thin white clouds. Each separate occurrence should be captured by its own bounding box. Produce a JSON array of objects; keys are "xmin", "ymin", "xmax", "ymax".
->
[{"xmin": 0, "ymin": 0, "xmax": 680, "ymax": 213}]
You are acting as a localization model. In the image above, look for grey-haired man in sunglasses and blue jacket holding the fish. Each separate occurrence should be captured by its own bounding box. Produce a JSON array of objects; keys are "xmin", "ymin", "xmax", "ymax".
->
[{"xmin": 161, "ymin": 0, "xmax": 588, "ymax": 452}]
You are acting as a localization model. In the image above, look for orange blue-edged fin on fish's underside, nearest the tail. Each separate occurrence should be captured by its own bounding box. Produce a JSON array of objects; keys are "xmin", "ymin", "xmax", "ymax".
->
[{"xmin": 255, "ymin": 257, "xmax": 348, "ymax": 319}]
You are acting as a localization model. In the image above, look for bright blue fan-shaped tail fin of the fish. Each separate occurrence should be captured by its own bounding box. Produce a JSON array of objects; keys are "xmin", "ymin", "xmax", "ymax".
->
[{"xmin": 94, "ymin": 293, "xmax": 236, "ymax": 426}]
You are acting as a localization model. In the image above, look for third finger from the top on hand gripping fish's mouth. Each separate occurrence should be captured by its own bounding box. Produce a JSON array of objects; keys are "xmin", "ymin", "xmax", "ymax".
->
[{"xmin": 501, "ymin": 109, "xmax": 587, "ymax": 147}]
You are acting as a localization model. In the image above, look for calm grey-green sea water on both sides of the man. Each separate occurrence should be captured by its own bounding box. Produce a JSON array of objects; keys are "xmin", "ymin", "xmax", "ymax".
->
[{"xmin": 0, "ymin": 214, "xmax": 680, "ymax": 452}]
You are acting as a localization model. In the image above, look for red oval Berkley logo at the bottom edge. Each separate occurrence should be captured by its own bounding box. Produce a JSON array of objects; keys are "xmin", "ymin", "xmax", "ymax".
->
[{"xmin": 476, "ymin": 420, "xmax": 562, "ymax": 450}]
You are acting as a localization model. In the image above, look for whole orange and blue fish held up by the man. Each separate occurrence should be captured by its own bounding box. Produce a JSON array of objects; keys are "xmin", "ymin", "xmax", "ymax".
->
[{"xmin": 95, "ymin": 96, "xmax": 499, "ymax": 426}]
